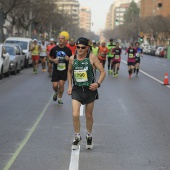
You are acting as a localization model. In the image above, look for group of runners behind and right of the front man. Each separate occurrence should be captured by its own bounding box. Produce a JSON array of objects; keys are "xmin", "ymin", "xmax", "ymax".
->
[{"xmin": 92, "ymin": 38, "xmax": 143, "ymax": 78}]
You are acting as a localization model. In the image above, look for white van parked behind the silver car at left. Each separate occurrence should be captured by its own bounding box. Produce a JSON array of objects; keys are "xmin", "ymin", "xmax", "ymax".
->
[{"xmin": 4, "ymin": 37, "xmax": 33, "ymax": 68}]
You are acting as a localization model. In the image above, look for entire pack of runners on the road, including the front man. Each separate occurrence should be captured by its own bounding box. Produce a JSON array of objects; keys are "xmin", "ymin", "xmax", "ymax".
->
[{"xmin": 31, "ymin": 35, "xmax": 142, "ymax": 150}]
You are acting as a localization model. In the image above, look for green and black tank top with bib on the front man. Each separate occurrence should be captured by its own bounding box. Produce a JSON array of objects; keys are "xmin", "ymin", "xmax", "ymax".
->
[{"xmin": 73, "ymin": 54, "xmax": 95, "ymax": 86}]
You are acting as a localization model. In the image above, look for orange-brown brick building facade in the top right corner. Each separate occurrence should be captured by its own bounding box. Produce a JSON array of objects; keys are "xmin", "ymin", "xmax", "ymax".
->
[{"xmin": 140, "ymin": 0, "xmax": 170, "ymax": 17}]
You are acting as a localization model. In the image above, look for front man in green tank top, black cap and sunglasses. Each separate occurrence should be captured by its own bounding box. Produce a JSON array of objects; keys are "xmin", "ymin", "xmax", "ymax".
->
[{"xmin": 68, "ymin": 37, "xmax": 106, "ymax": 150}]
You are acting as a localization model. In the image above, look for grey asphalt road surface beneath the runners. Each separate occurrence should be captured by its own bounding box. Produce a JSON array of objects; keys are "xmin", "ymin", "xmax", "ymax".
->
[{"xmin": 0, "ymin": 55, "xmax": 170, "ymax": 170}]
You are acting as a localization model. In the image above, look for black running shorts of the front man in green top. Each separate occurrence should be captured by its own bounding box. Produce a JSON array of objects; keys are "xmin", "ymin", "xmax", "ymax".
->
[{"xmin": 72, "ymin": 86, "xmax": 98, "ymax": 105}]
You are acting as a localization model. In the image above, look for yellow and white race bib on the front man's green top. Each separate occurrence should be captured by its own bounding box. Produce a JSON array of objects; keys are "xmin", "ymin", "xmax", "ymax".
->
[{"xmin": 74, "ymin": 70, "xmax": 88, "ymax": 82}]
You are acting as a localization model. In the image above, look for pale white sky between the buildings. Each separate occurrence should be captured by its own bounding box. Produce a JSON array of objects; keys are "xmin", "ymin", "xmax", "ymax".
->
[{"xmin": 79, "ymin": 0, "xmax": 114, "ymax": 32}]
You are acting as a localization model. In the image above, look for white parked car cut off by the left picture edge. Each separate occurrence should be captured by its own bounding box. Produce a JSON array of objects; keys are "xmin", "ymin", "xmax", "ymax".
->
[{"xmin": 0, "ymin": 44, "xmax": 10, "ymax": 79}]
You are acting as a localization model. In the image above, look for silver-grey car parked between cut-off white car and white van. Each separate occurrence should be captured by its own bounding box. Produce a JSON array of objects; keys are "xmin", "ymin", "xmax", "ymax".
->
[{"xmin": 4, "ymin": 44, "xmax": 21, "ymax": 75}]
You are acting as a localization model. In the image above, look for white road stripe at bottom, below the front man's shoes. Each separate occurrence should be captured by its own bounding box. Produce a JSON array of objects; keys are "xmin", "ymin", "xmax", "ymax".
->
[{"xmin": 69, "ymin": 146, "xmax": 80, "ymax": 170}]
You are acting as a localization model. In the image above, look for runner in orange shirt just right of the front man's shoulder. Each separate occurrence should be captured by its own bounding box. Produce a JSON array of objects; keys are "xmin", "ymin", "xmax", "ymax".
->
[{"xmin": 98, "ymin": 42, "xmax": 109, "ymax": 68}]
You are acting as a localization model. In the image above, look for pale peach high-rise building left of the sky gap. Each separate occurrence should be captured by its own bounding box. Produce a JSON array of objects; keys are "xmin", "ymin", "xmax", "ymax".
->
[{"xmin": 79, "ymin": 7, "xmax": 92, "ymax": 32}]
